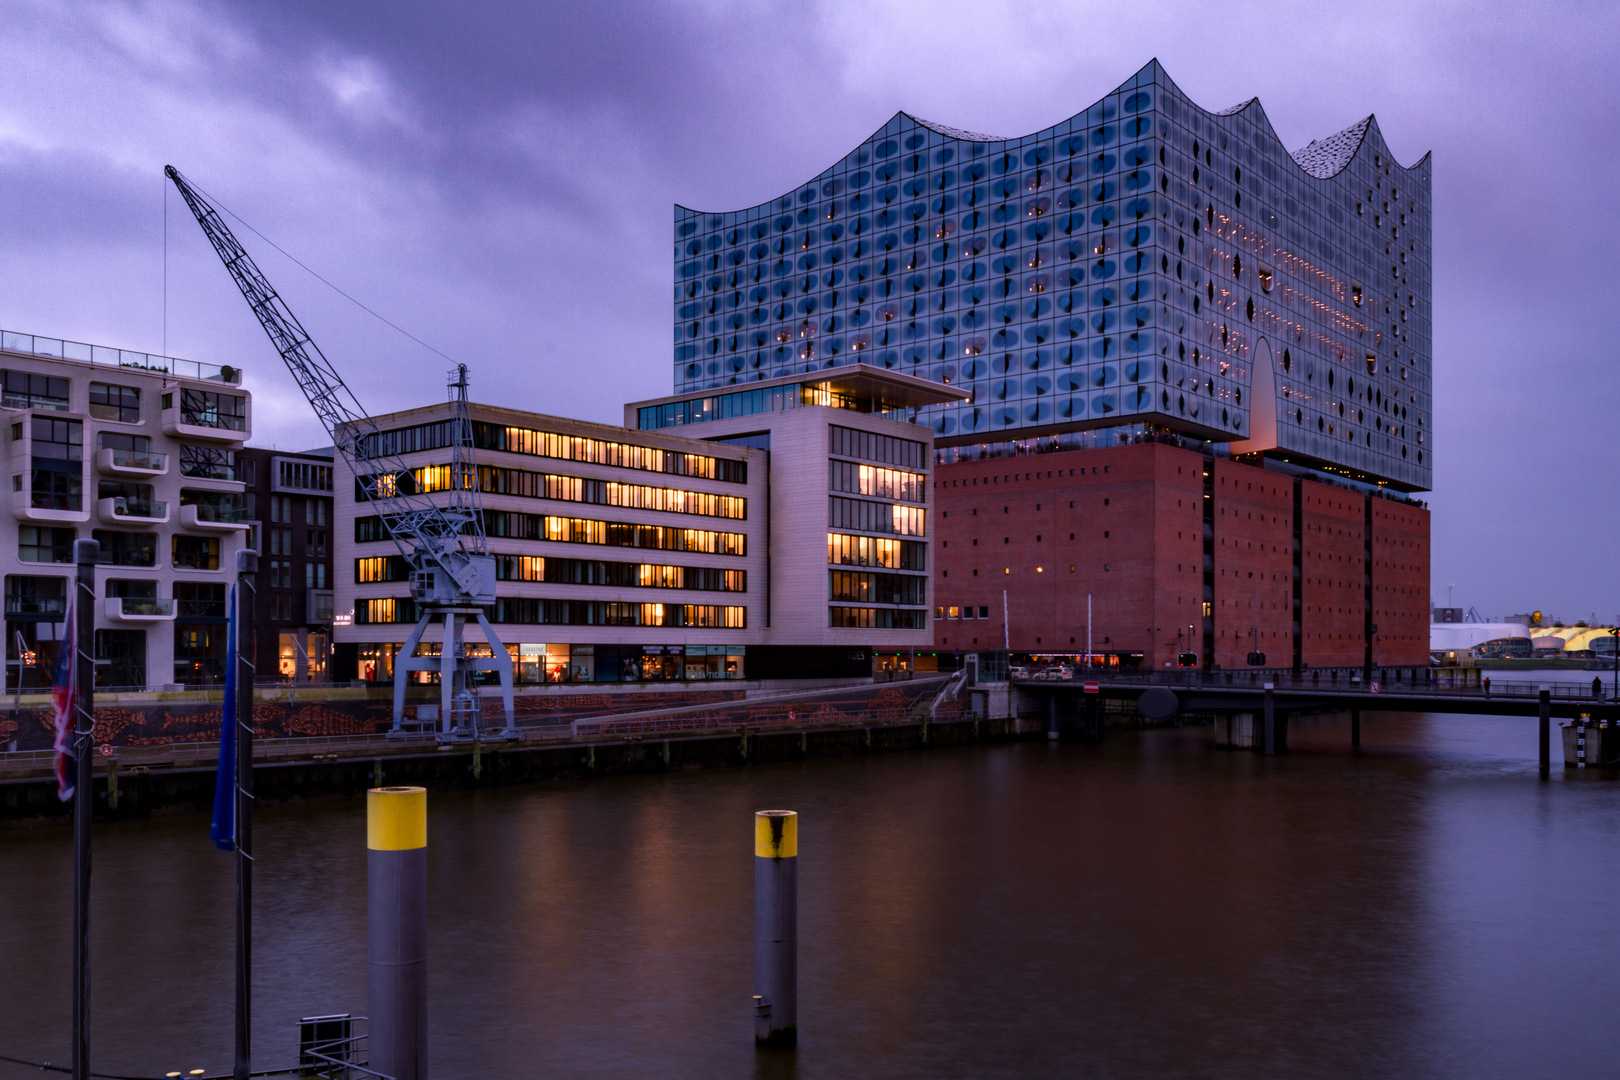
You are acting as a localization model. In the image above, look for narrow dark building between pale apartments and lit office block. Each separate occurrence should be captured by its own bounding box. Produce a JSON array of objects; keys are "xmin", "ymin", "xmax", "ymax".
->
[{"xmin": 240, "ymin": 447, "xmax": 335, "ymax": 682}]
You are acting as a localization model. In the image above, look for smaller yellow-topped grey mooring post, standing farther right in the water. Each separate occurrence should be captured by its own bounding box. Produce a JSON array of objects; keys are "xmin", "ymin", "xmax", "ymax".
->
[{"xmin": 753, "ymin": 810, "xmax": 799, "ymax": 1046}]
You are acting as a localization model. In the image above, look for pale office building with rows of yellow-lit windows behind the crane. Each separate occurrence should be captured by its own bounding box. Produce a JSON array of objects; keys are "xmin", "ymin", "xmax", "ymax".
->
[{"xmin": 334, "ymin": 380, "xmax": 941, "ymax": 685}]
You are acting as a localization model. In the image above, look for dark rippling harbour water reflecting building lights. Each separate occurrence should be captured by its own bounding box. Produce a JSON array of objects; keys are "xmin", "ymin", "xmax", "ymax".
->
[{"xmin": 0, "ymin": 716, "xmax": 1620, "ymax": 1078}]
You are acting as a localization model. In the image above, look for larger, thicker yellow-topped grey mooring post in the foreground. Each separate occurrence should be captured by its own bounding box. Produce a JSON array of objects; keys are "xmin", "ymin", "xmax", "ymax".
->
[{"xmin": 366, "ymin": 787, "xmax": 428, "ymax": 1080}]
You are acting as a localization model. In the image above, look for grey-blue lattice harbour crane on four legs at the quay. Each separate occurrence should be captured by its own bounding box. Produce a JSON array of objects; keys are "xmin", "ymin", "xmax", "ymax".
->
[{"xmin": 164, "ymin": 165, "xmax": 517, "ymax": 738}]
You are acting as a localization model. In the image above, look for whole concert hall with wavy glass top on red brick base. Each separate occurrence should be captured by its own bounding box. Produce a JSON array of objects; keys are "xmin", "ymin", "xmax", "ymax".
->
[{"xmin": 674, "ymin": 62, "xmax": 1434, "ymax": 669}]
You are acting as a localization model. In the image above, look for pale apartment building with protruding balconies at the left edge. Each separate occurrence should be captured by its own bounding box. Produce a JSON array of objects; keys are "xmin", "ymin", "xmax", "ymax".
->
[{"xmin": 0, "ymin": 332, "xmax": 253, "ymax": 690}]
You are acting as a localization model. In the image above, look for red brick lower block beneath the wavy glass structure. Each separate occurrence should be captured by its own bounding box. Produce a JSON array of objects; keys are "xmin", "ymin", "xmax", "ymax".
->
[{"xmin": 933, "ymin": 442, "xmax": 1429, "ymax": 669}]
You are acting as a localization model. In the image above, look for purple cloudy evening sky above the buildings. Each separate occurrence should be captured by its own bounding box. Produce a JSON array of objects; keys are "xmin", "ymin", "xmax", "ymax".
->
[{"xmin": 0, "ymin": 0, "xmax": 1620, "ymax": 620}]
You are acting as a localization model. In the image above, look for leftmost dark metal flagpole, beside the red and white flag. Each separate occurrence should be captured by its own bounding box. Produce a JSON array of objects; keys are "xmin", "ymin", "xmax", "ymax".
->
[{"xmin": 62, "ymin": 541, "xmax": 100, "ymax": 1080}]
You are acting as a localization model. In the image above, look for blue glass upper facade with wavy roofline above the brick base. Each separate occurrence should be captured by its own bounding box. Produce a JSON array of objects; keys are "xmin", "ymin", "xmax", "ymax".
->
[{"xmin": 677, "ymin": 62, "xmax": 1434, "ymax": 491}]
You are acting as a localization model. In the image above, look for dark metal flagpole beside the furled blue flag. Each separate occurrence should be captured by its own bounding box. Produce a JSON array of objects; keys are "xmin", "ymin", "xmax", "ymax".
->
[{"xmin": 235, "ymin": 551, "xmax": 259, "ymax": 1080}]
